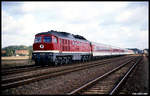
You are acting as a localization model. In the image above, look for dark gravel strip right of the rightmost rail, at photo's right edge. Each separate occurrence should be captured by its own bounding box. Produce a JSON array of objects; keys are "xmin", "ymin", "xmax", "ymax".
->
[{"xmin": 120, "ymin": 56, "xmax": 149, "ymax": 95}]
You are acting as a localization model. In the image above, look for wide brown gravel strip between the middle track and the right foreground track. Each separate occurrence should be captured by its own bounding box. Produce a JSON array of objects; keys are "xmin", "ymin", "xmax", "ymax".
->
[{"xmin": 3, "ymin": 55, "xmax": 137, "ymax": 95}]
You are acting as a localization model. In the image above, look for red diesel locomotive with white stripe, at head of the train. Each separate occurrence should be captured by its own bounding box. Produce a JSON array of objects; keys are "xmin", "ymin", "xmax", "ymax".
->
[{"xmin": 32, "ymin": 30, "xmax": 91, "ymax": 65}]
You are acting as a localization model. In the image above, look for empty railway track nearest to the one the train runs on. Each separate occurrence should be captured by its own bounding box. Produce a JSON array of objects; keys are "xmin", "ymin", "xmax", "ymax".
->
[{"xmin": 1, "ymin": 57, "xmax": 133, "ymax": 90}]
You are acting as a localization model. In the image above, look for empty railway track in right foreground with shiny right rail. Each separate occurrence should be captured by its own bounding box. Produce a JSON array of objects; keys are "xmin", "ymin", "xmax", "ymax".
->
[{"xmin": 67, "ymin": 57, "xmax": 142, "ymax": 95}]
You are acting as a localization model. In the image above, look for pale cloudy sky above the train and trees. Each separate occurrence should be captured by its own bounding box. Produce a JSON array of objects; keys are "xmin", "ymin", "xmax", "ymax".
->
[{"xmin": 1, "ymin": 1, "xmax": 149, "ymax": 49}]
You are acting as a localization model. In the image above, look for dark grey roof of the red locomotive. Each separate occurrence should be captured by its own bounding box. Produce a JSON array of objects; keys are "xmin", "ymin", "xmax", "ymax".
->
[{"xmin": 36, "ymin": 30, "xmax": 87, "ymax": 41}]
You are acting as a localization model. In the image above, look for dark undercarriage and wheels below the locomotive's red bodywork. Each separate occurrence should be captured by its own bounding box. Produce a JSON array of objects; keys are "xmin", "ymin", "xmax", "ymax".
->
[{"xmin": 32, "ymin": 51, "xmax": 91, "ymax": 65}]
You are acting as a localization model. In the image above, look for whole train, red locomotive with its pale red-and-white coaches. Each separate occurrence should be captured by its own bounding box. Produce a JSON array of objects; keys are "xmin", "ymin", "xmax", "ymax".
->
[{"xmin": 32, "ymin": 30, "xmax": 133, "ymax": 66}]
